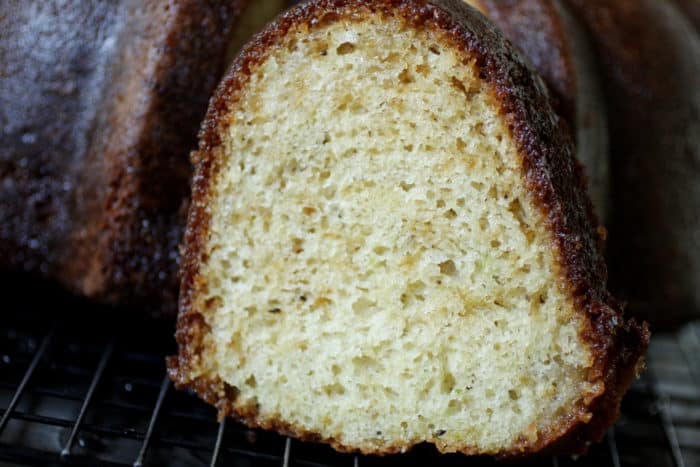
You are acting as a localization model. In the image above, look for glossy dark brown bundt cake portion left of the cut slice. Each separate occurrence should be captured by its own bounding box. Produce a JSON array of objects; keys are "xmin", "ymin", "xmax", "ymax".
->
[{"xmin": 0, "ymin": 0, "xmax": 283, "ymax": 312}]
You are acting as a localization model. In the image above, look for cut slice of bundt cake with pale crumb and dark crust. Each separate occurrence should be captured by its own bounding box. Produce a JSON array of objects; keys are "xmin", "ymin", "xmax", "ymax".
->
[{"xmin": 169, "ymin": 0, "xmax": 648, "ymax": 457}]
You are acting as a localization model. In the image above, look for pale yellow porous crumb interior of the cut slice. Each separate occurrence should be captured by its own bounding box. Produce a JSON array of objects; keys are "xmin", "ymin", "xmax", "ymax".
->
[{"xmin": 193, "ymin": 18, "xmax": 596, "ymax": 458}]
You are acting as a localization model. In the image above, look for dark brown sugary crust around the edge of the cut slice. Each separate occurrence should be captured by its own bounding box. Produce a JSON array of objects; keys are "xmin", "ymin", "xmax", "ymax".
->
[{"xmin": 168, "ymin": 0, "xmax": 649, "ymax": 457}]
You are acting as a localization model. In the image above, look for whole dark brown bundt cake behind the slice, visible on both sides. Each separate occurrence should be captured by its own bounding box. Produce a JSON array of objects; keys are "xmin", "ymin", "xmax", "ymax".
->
[{"xmin": 0, "ymin": 0, "xmax": 700, "ymax": 330}]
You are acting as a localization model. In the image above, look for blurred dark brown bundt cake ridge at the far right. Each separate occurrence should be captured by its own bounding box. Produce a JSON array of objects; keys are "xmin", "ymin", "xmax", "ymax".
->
[{"xmin": 568, "ymin": 0, "xmax": 700, "ymax": 326}]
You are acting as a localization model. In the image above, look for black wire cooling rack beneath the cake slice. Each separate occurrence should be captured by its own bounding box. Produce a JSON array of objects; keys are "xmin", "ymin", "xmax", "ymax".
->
[{"xmin": 0, "ymin": 278, "xmax": 700, "ymax": 467}]
